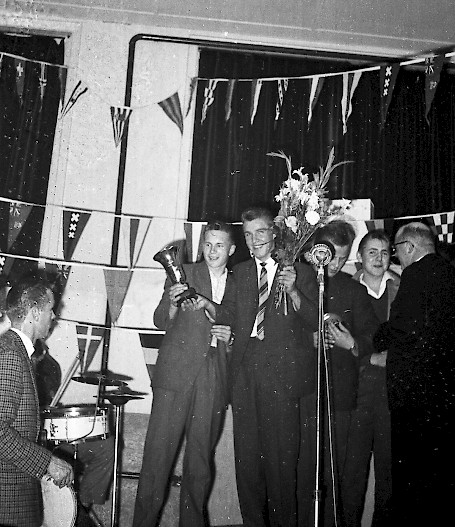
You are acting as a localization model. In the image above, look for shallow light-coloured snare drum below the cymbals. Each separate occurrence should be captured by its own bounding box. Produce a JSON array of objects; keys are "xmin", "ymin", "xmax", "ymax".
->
[{"xmin": 42, "ymin": 405, "xmax": 109, "ymax": 445}]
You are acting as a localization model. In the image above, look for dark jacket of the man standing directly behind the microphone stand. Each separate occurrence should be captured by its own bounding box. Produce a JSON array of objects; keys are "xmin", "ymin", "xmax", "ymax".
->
[{"xmin": 306, "ymin": 271, "xmax": 379, "ymax": 411}]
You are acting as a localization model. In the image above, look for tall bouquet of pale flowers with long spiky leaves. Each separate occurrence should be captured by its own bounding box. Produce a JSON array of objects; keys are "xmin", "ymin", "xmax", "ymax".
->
[{"xmin": 267, "ymin": 148, "xmax": 350, "ymax": 314}]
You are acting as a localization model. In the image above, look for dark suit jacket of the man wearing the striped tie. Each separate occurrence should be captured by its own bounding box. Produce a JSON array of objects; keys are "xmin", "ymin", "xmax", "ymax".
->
[{"xmin": 217, "ymin": 259, "xmax": 318, "ymax": 397}]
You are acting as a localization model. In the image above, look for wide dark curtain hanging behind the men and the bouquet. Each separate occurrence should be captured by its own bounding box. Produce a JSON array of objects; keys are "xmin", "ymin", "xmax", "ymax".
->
[{"xmin": 189, "ymin": 50, "xmax": 455, "ymax": 221}]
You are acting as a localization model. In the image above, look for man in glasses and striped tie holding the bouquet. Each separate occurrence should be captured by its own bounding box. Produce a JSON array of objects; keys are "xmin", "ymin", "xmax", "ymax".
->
[{"xmin": 200, "ymin": 208, "xmax": 318, "ymax": 527}]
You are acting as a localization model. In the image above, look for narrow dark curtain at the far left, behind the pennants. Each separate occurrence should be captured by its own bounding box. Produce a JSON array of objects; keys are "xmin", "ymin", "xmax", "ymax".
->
[{"xmin": 0, "ymin": 33, "xmax": 64, "ymax": 279}]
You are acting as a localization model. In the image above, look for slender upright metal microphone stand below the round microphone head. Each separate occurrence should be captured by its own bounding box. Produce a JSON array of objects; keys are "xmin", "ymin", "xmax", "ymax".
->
[{"xmin": 314, "ymin": 262, "xmax": 324, "ymax": 527}]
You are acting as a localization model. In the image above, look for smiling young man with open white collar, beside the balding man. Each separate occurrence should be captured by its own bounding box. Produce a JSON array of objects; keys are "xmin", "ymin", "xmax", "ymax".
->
[{"xmin": 342, "ymin": 230, "xmax": 400, "ymax": 527}]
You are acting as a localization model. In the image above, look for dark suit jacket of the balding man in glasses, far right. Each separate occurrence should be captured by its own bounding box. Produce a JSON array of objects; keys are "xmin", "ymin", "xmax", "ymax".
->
[{"xmin": 375, "ymin": 254, "xmax": 455, "ymax": 416}]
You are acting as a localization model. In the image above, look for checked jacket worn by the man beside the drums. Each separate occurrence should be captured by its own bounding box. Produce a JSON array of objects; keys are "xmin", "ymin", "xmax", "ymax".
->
[{"xmin": 0, "ymin": 330, "xmax": 51, "ymax": 525}]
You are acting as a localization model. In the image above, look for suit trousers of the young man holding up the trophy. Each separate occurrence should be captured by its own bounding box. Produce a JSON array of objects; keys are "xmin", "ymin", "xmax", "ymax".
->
[{"xmin": 133, "ymin": 348, "xmax": 226, "ymax": 527}]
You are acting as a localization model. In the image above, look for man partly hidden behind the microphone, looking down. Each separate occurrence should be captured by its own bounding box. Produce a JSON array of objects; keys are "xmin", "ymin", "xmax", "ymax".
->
[{"xmin": 299, "ymin": 220, "xmax": 379, "ymax": 527}]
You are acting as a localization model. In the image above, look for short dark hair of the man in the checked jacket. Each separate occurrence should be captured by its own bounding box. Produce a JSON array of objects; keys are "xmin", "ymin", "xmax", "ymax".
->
[{"xmin": 6, "ymin": 275, "xmax": 52, "ymax": 322}]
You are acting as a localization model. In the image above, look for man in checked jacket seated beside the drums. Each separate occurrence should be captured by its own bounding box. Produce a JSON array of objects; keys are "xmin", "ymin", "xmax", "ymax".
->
[{"xmin": 0, "ymin": 279, "xmax": 74, "ymax": 527}]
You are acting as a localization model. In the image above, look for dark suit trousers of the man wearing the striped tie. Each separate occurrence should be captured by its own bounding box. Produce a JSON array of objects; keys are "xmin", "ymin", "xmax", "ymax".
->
[{"xmin": 232, "ymin": 339, "xmax": 300, "ymax": 527}]
